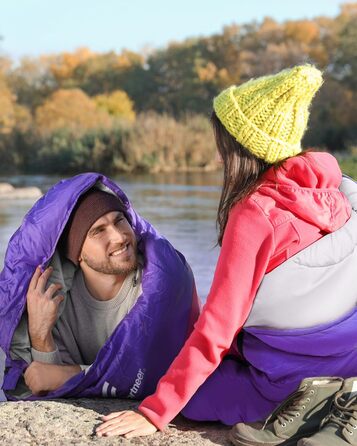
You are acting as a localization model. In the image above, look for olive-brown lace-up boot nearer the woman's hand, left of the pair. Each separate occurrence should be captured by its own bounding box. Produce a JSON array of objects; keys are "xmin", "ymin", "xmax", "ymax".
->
[{"xmin": 229, "ymin": 377, "xmax": 343, "ymax": 446}]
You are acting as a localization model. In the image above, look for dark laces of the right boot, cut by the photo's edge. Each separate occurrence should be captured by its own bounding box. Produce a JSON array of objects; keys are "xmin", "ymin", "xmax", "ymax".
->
[{"xmin": 320, "ymin": 392, "xmax": 357, "ymax": 435}]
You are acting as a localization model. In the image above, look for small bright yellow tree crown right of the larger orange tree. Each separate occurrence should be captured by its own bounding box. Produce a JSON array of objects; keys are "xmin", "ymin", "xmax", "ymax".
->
[{"xmin": 93, "ymin": 90, "xmax": 135, "ymax": 122}]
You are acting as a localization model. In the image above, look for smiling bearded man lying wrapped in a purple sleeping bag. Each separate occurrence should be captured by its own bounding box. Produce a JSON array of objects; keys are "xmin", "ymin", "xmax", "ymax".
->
[{"xmin": 0, "ymin": 173, "xmax": 199, "ymax": 401}]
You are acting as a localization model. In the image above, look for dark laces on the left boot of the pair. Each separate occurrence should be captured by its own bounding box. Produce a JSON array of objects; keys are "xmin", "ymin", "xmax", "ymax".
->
[{"xmin": 262, "ymin": 387, "xmax": 315, "ymax": 429}]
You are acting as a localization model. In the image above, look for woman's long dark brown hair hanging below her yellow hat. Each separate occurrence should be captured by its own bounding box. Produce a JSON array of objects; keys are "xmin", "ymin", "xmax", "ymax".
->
[{"xmin": 211, "ymin": 112, "xmax": 272, "ymax": 246}]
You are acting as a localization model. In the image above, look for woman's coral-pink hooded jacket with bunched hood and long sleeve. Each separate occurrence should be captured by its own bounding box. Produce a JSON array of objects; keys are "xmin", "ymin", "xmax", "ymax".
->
[{"xmin": 139, "ymin": 152, "xmax": 351, "ymax": 429}]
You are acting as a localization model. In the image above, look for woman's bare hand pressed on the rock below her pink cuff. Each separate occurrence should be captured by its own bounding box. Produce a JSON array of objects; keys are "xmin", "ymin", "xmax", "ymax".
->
[{"xmin": 96, "ymin": 410, "xmax": 157, "ymax": 438}]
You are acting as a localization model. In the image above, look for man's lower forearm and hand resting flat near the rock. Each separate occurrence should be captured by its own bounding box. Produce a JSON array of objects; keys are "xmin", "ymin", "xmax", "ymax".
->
[{"xmin": 24, "ymin": 361, "xmax": 81, "ymax": 395}]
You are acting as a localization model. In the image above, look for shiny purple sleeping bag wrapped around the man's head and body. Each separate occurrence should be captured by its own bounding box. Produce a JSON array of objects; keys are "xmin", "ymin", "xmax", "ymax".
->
[{"xmin": 0, "ymin": 173, "xmax": 199, "ymax": 401}]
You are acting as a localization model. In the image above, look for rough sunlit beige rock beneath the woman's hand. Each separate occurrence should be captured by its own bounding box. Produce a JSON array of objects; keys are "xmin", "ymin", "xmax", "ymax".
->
[{"xmin": 0, "ymin": 398, "xmax": 230, "ymax": 446}]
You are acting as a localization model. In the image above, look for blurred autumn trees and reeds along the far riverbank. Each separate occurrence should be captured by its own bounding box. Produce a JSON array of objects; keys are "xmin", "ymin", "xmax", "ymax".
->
[{"xmin": 0, "ymin": 2, "xmax": 357, "ymax": 173}]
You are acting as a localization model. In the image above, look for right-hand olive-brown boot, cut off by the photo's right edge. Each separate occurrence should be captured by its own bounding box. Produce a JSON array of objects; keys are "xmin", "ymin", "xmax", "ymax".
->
[{"xmin": 298, "ymin": 378, "xmax": 357, "ymax": 446}]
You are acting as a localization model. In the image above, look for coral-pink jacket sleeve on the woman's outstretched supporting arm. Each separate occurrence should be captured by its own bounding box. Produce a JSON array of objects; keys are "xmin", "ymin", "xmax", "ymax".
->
[{"xmin": 139, "ymin": 199, "xmax": 275, "ymax": 429}]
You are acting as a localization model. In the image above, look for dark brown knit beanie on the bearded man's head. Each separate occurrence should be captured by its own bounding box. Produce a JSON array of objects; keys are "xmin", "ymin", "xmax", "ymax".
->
[{"xmin": 61, "ymin": 189, "xmax": 126, "ymax": 266}]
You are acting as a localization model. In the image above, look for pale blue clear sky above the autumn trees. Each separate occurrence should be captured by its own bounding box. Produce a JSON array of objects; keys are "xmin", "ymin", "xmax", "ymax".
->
[{"xmin": 0, "ymin": 0, "xmax": 344, "ymax": 60}]
